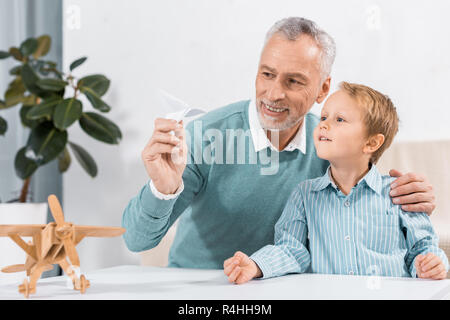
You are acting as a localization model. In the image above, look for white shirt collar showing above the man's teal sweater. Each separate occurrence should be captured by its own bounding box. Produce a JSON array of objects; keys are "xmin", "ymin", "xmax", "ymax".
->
[{"xmin": 248, "ymin": 99, "xmax": 306, "ymax": 154}]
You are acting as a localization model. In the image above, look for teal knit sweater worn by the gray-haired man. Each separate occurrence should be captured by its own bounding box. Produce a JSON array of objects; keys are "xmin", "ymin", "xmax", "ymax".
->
[{"xmin": 122, "ymin": 101, "xmax": 329, "ymax": 269}]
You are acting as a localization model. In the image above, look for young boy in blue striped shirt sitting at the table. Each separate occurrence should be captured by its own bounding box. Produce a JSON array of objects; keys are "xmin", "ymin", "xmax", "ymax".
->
[{"xmin": 224, "ymin": 82, "xmax": 449, "ymax": 284}]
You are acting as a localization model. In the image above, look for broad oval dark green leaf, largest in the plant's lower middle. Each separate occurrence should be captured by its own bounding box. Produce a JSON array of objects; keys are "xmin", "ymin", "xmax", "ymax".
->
[{"xmin": 27, "ymin": 121, "xmax": 67, "ymax": 165}]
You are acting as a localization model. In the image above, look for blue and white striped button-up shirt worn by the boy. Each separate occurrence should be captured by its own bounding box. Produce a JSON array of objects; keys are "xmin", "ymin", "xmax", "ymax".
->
[{"xmin": 250, "ymin": 165, "xmax": 449, "ymax": 278}]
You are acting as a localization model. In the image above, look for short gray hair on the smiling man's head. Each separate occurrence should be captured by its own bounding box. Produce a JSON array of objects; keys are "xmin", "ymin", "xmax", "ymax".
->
[{"xmin": 264, "ymin": 17, "xmax": 336, "ymax": 80}]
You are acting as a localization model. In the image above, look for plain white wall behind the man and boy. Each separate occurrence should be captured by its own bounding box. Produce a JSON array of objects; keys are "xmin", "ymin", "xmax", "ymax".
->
[{"xmin": 63, "ymin": 0, "xmax": 450, "ymax": 270}]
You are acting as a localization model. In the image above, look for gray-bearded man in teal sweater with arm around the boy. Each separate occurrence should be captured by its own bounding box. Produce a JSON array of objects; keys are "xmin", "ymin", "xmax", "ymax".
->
[{"xmin": 122, "ymin": 18, "xmax": 435, "ymax": 268}]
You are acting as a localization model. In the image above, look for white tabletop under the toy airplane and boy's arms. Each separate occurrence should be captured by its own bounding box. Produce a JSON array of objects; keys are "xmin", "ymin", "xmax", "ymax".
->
[{"xmin": 0, "ymin": 266, "xmax": 450, "ymax": 300}]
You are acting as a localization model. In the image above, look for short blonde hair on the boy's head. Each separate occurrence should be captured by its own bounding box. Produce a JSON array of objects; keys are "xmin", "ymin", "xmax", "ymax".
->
[{"xmin": 339, "ymin": 81, "xmax": 399, "ymax": 164}]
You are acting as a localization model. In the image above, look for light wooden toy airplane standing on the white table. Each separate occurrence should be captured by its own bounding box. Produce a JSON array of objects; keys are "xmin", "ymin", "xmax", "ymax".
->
[{"xmin": 0, "ymin": 194, "xmax": 125, "ymax": 298}]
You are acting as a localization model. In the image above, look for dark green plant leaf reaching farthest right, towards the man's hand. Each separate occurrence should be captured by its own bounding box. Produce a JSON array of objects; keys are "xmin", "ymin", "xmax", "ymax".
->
[{"xmin": 79, "ymin": 112, "xmax": 122, "ymax": 144}]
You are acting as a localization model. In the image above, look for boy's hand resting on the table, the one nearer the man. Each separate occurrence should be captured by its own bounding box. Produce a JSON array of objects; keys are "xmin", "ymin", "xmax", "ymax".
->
[{"xmin": 223, "ymin": 251, "xmax": 262, "ymax": 284}]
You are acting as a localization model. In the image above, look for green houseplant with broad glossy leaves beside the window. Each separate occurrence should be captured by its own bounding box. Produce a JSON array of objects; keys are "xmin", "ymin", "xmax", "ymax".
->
[{"xmin": 0, "ymin": 35, "xmax": 122, "ymax": 202}]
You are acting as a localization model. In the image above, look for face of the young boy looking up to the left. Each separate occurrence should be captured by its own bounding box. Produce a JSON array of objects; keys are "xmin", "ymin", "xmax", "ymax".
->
[{"xmin": 314, "ymin": 90, "xmax": 367, "ymax": 163}]
